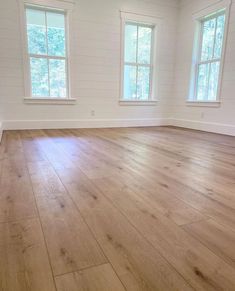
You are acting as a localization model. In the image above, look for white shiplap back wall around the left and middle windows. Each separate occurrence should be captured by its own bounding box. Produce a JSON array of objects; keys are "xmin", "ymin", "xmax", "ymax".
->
[{"xmin": 0, "ymin": 0, "xmax": 179, "ymax": 129}]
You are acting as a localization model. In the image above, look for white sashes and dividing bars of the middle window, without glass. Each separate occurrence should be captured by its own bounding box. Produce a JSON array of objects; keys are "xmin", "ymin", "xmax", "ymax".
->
[{"xmin": 122, "ymin": 21, "xmax": 154, "ymax": 101}]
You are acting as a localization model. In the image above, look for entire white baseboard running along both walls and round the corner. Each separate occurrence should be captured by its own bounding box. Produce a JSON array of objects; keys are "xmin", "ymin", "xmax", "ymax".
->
[{"xmin": 0, "ymin": 118, "xmax": 235, "ymax": 140}]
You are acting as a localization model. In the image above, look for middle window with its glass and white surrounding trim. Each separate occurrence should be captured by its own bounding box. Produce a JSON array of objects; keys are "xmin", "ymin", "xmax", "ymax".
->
[{"xmin": 121, "ymin": 12, "xmax": 160, "ymax": 104}]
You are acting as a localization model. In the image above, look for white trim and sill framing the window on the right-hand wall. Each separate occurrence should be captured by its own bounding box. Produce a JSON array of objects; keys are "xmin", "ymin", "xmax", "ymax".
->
[{"xmin": 187, "ymin": 0, "xmax": 231, "ymax": 107}]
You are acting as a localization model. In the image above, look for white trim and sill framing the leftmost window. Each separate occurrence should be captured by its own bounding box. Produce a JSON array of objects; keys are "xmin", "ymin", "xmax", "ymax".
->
[{"xmin": 19, "ymin": 0, "xmax": 76, "ymax": 104}]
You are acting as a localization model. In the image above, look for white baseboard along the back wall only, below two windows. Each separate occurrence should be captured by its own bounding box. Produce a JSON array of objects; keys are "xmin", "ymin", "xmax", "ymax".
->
[{"xmin": 3, "ymin": 118, "xmax": 169, "ymax": 130}]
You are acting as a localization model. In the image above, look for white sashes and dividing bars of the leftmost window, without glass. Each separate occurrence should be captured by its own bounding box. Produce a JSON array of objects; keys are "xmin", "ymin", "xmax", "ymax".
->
[{"xmin": 25, "ymin": 5, "xmax": 69, "ymax": 99}]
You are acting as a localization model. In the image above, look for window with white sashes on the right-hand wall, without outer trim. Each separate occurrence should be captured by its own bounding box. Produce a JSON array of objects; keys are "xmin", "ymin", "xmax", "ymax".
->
[{"xmin": 189, "ymin": 5, "xmax": 229, "ymax": 102}]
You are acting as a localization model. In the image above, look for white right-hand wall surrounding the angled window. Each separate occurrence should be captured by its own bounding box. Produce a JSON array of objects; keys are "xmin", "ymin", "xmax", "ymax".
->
[{"xmin": 171, "ymin": 0, "xmax": 235, "ymax": 135}]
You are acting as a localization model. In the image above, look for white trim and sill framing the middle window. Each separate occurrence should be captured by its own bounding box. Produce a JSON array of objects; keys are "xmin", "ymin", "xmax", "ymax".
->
[{"xmin": 119, "ymin": 11, "xmax": 161, "ymax": 105}]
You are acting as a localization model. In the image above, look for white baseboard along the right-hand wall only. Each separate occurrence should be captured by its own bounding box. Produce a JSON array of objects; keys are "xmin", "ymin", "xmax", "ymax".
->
[{"xmin": 169, "ymin": 118, "xmax": 235, "ymax": 136}]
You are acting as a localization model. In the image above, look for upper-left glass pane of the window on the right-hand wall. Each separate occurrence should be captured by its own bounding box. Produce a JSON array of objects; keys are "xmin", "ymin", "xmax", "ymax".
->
[{"xmin": 201, "ymin": 18, "xmax": 216, "ymax": 61}]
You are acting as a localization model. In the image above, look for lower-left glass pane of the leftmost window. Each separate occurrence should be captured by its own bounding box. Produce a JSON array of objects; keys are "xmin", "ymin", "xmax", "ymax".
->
[{"xmin": 30, "ymin": 58, "xmax": 49, "ymax": 97}]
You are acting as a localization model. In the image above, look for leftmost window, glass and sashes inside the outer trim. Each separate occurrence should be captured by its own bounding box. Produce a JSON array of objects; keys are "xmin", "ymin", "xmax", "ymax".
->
[{"xmin": 26, "ymin": 6, "xmax": 68, "ymax": 98}]
